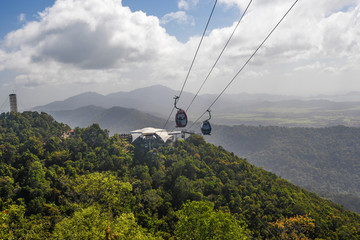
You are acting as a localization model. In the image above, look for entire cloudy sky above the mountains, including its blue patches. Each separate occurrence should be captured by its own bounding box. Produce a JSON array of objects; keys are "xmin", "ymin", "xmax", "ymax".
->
[{"xmin": 0, "ymin": 0, "xmax": 360, "ymax": 110}]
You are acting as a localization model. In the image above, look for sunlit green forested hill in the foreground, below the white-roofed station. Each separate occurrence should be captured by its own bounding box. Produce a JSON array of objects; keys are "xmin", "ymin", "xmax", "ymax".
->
[{"xmin": 0, "ymin": 112, "xmax": 360, "ymax": 240}]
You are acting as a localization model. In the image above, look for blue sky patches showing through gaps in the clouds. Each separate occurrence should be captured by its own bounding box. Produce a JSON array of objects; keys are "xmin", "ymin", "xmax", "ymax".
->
[{"xmin": 0, "ymin": 0, "xmax": 239, "ymax": 42}]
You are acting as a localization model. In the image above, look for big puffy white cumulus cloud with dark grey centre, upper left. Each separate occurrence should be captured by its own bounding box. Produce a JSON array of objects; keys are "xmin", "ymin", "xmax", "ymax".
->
[{"xmin": 5, "ymin": 0, "xmax": 180, "ymax": 69}]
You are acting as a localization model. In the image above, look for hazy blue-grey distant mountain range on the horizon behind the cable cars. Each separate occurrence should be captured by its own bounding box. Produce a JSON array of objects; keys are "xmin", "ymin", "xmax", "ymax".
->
[{"xmin": 33, "ymin": 85, "xmax": 293, "ymax": 117}]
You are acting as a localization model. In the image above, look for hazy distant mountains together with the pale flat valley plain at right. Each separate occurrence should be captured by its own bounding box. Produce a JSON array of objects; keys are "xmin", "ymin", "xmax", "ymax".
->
[{"xmin": 33, "ymin": 85, "xmax": 360, "ymax": 127}]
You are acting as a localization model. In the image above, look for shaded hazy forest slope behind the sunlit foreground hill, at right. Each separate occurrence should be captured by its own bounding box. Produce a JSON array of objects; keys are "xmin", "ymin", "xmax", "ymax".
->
[{"xmin": 208, "ymin": 125, "xmax": 360, "ymax": 212}]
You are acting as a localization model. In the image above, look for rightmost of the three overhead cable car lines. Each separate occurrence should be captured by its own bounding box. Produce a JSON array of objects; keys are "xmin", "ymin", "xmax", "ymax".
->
[{"xmin": 189, "ymin": 0, "xmax": 299, "ymax": 129}]
